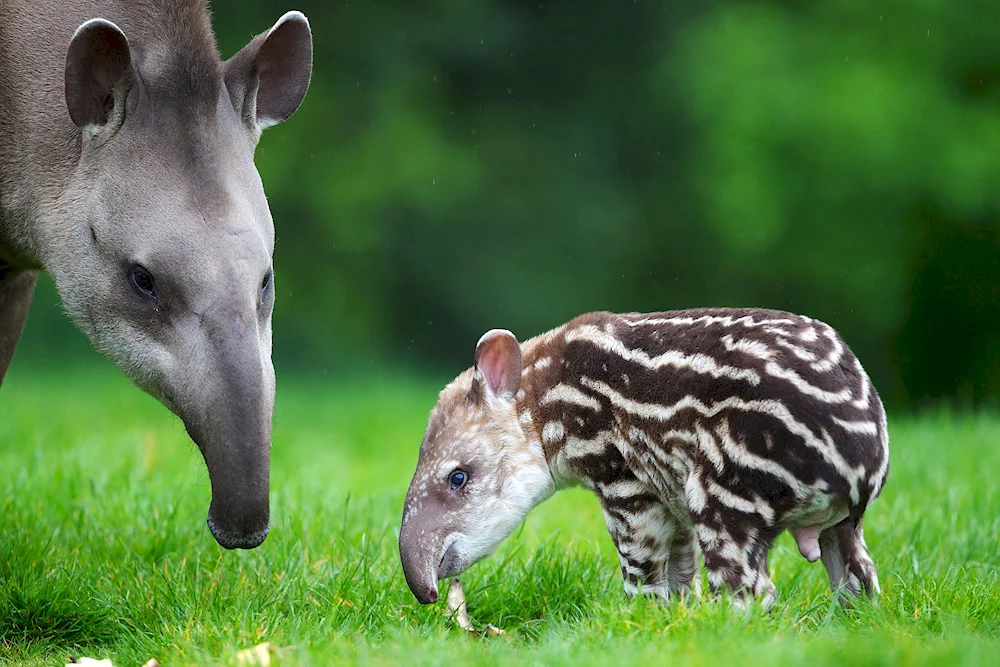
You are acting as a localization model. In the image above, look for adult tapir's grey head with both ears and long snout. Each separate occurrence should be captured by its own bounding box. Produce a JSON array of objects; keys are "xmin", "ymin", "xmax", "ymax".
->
[{"xmin": 44, "ymin": 2, "xmax": 312, "ymax": 549}]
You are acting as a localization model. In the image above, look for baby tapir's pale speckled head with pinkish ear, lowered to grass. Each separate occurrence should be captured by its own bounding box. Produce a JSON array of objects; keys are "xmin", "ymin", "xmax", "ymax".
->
[{"xmin": 399, "ymin": 329, "xmax": 555, "ymax": 604}]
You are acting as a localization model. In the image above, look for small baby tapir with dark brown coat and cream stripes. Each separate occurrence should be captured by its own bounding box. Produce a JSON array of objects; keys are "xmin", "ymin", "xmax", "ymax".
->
[{"xmin": 399, "ymin": 309, "xmax": 889, "ymax": 606}]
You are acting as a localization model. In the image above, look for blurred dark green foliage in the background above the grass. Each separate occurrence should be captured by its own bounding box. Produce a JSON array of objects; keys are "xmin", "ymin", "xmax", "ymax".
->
[{"xmin": 13, "ymin": 0, "xmax": 1000, "ymax": 406}]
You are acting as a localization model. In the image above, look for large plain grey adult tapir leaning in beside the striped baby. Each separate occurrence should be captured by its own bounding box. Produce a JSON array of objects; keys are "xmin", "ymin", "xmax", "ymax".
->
[{"xmin": 0, "ymin": 0, "xmax": 312, "ymax": 549}]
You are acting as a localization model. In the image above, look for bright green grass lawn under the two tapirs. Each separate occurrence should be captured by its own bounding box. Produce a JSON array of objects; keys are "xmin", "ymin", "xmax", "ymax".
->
[{"xmin": 0, "ymin": 364, "xmax": 1000, "ymax": 667}]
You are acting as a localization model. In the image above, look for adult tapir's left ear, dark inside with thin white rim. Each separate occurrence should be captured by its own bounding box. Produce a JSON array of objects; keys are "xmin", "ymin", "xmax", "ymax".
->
[{"xmin": 65, "ymin": 19, "xmax": 132, "ymax": 127}]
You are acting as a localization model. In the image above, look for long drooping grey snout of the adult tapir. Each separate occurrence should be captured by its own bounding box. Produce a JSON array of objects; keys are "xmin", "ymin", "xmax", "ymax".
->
[{"xmin": 169, "ymin": 310, "xmax": 274, "ymax": 549}]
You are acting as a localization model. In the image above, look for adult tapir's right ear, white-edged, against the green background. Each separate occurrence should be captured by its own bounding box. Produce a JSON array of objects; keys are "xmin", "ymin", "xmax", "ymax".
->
[{"xmin": 225, "ymin": 12, "xmax": 312, "ymax": 131}]
